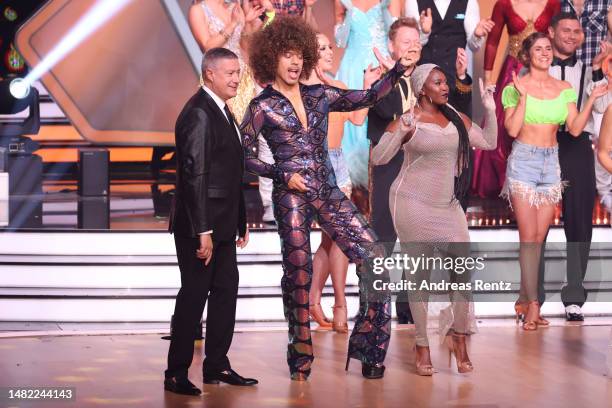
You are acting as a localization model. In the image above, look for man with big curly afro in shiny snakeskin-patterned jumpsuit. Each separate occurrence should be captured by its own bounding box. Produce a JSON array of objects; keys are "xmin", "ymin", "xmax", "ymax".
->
[{"xmin": 241, "ymin": 17, "xmax": 416, "ymax": 381}]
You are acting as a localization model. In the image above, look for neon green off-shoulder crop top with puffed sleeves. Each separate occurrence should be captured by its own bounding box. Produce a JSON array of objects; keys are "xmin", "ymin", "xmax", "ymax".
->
[{"xmin": 502, "ymin": 85, "xmax": 578, "ymax": 125}]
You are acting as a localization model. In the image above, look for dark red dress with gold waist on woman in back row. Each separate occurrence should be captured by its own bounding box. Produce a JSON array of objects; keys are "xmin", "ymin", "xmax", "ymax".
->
[{"xmin": 472, "ymin": 0, "xmax": 561, "ymax": 198}]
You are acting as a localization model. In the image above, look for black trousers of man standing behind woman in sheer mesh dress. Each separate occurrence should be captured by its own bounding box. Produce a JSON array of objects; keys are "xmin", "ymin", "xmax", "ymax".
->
[{"xmin": 370, "ymin": 152, "xmax": 414, "ymax": 322}]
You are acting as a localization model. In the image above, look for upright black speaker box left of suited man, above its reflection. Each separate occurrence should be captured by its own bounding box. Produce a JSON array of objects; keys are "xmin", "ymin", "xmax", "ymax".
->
[{"xmin": 78, "ymin": 149, "xmax": 110, "ymax": 197}]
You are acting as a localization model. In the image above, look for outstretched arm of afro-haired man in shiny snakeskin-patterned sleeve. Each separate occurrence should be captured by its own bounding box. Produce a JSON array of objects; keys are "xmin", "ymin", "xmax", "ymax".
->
[{"xmin": 325, "ymin": 62, "xmax": 406, "ymax": 112}]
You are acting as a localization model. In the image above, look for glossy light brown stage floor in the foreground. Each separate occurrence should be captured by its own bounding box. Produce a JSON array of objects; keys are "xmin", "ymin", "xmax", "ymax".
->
[{"xmin": 0, "ymin": 318, "xmax": 612, "ymax": 408}]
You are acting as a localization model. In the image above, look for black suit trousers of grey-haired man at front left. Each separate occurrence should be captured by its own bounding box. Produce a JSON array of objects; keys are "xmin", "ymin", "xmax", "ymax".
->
[{"xmin": 165, "ymin": 235, "xmax": 238, "ymax": 378}]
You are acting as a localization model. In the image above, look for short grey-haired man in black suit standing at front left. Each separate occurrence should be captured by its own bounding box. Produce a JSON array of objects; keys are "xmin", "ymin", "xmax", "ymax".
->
[{"xmin": 164, "ymin": 48, "xmax": 257, "ymax": 395}]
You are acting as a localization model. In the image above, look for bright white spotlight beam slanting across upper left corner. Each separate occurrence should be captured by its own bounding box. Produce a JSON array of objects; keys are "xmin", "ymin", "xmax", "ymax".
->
[{"xmin": 24, "ymin": 0, "xmax": 132, "ymax": 87}]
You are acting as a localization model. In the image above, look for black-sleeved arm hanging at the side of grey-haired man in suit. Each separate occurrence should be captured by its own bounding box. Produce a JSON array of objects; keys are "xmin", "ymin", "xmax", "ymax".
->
[{"xmin": 175, "ymin": 109, "xmax": 212, "ymax": 234}]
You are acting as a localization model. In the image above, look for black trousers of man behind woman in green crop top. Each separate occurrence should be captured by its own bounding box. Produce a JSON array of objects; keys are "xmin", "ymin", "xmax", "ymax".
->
[{"xmin": 538, "ymin": 132, "xmax": 597, "ymax": 306}]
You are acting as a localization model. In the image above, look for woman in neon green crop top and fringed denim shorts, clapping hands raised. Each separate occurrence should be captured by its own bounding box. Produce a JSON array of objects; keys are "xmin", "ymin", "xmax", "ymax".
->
[{"xmin": 502, "ymin": 32, "xmax": 606, "ymax": 330}]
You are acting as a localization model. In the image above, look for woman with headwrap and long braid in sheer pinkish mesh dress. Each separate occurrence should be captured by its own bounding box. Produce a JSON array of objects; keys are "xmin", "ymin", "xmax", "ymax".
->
[{"xmin": 372, "ymin": 64, "xmax": 497, "ymax": 376}]
